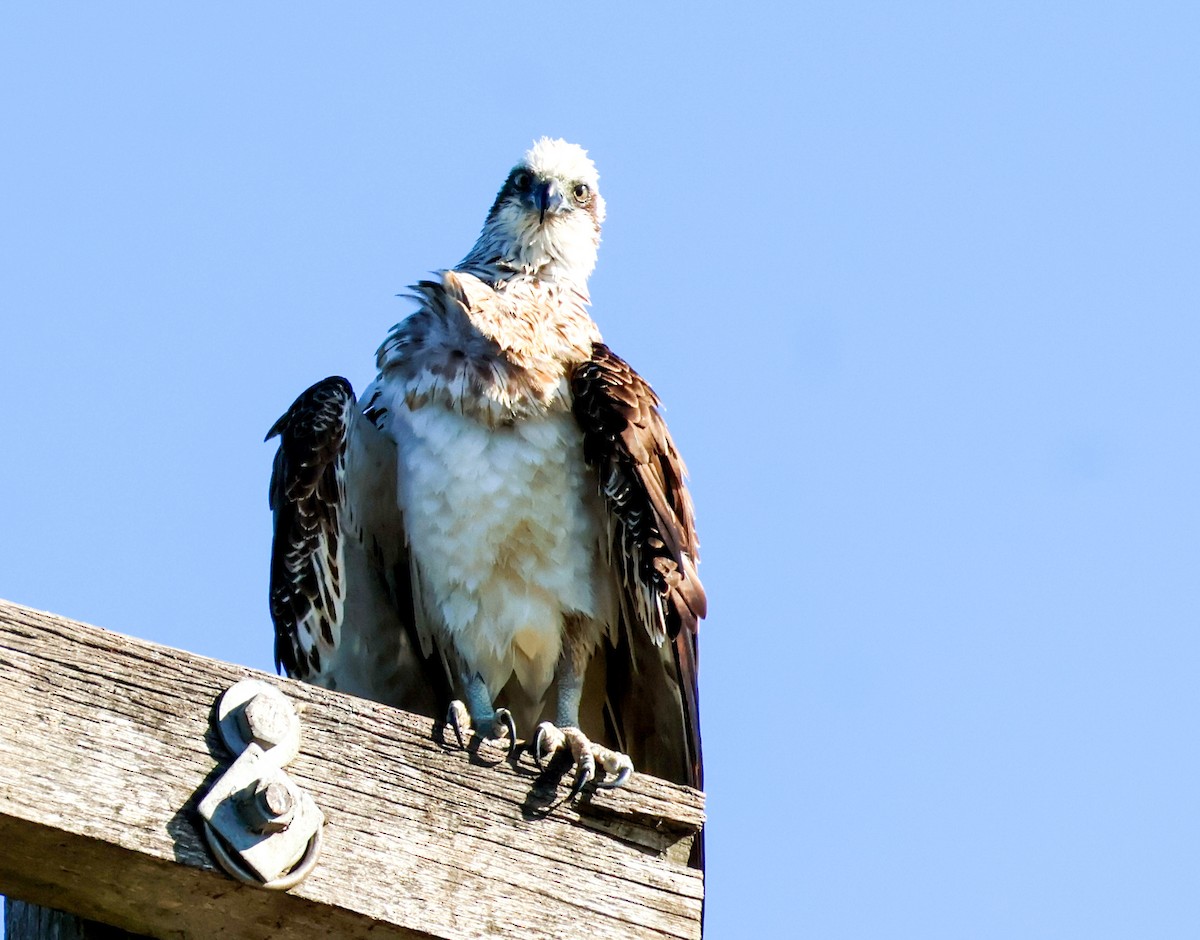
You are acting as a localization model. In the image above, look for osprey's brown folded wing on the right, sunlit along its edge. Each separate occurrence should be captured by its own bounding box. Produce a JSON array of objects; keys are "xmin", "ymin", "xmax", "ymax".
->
[{"xmin": 571, "ymin": 343, "xmax": 707, "ymax": 788}]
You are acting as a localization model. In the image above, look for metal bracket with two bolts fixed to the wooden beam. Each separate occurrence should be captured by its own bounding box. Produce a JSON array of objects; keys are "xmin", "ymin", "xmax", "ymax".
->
[{"xmin": 199, "ymin": 679, "xmax": 325, "ymax": 891}]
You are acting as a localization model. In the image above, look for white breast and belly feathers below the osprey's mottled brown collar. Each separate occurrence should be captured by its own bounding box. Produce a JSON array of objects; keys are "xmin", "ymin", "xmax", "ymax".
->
[{"xmin": 391, "ymin": 401, "xmax": 613, "ymax": 696}]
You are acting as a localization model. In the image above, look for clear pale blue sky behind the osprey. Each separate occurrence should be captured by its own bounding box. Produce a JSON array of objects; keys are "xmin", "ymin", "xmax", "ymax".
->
[{"xmin": 0, "ymin": 1, "xmax": 1200, "ymax": 940}]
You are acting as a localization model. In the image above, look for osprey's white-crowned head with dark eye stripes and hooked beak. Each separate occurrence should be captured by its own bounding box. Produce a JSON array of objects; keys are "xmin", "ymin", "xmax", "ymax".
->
[{"xmin": 464, "ymin": 137, "xmax": 605, "ymax": 287}]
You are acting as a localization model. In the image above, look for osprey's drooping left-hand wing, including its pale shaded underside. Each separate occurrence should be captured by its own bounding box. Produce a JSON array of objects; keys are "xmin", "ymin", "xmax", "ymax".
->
[{"xmin": 266, "ymin": 377, "xmax": 449, "ymax": 716}]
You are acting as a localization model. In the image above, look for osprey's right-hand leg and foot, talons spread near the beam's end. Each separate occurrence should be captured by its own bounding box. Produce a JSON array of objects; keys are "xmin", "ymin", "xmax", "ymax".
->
[{"xmin": 533, "ymin": 629, "xmax": 634, "ymax": 794}]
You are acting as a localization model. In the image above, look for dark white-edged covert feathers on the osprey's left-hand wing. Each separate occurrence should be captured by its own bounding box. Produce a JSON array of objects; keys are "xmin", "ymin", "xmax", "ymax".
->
[{"xmin": 266, "ymin": 376, "xmax": 358, "ymax": 678}]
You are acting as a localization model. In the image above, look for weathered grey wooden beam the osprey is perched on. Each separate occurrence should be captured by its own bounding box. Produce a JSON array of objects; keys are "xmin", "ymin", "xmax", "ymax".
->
[{"xmin": 0, "ymin": 601, "xmax": 704, "ymax": 940}]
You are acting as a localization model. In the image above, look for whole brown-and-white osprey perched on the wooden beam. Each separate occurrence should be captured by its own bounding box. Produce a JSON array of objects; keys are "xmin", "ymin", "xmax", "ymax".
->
[{"xmin": 268, "ymin": 138, "xmax": 706, "ymax": 789}]
